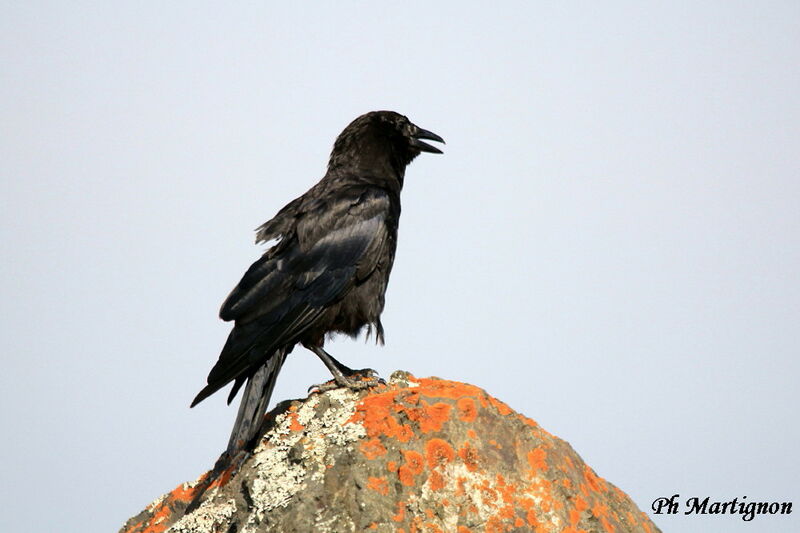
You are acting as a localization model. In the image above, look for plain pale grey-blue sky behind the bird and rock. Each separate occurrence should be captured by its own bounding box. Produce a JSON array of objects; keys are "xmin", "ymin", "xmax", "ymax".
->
[{"xmin": 0, "ymin": 1, "xmax": 800, "ymax": 533}]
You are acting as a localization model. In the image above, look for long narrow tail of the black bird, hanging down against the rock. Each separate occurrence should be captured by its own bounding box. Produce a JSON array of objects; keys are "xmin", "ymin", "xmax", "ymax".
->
[{"xmin": 228, "ymin": 350, "xmax": 287, "ymax": 457}]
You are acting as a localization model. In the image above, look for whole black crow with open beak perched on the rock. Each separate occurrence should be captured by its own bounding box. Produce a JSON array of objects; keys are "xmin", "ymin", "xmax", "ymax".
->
[{"xmin": 192, "ymin": 111, "xmax": 444, "ymax": 455}]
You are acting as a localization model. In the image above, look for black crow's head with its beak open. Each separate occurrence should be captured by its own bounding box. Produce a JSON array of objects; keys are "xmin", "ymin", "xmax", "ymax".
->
[{"xmin": 329, "ymin": 111, "xmax": 444, "ymax": 179}]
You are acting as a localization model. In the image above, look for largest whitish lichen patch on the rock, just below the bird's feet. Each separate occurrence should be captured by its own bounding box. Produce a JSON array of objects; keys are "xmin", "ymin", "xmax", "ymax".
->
[{"xmin": 243, "ymin": 389, "xmax": 366, "ymax": 533}]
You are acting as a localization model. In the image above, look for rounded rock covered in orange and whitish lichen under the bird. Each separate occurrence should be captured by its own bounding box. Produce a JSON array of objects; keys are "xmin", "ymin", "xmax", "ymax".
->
[{"xmin": 121, "ymin": 372, "xmax": 659, "ymax": 533}]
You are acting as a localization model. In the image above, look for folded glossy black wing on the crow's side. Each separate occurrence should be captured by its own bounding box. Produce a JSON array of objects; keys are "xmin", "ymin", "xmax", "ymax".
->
[{"xmin": 197, "ymin": 189, "xmax": 388, "ymax": 397}]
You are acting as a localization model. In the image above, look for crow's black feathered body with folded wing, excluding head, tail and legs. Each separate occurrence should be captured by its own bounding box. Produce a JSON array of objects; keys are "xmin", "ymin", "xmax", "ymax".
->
[{"xmin": 195, "ymin": 175, "xmax": 400, "ymax": 403}]
